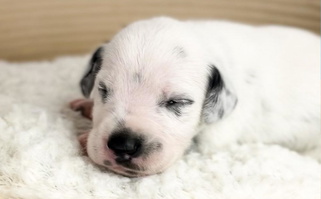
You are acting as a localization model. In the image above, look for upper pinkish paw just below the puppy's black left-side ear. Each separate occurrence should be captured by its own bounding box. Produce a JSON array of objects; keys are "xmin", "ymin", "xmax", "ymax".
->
[{"xmin": 69, "ymin": 99, "xmax": 94, "ymax": 120}]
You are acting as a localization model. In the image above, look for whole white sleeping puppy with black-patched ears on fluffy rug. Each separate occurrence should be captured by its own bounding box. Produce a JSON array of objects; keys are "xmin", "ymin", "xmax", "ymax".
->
[{"xmin": 71, "ymin": 17, "xmax": 320, "ymax": 176}]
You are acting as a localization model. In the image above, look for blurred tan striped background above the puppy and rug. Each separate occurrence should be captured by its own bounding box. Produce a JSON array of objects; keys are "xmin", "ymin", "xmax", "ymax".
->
[{"xmin": 0, "ymin": 0, "xmax": 320, "ymax": 61}]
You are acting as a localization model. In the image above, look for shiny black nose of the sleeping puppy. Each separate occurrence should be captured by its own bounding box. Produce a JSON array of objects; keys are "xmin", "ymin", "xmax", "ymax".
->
[{"xmin": 107, "ymin": 133, "xmax": 142, "ymax": 157}]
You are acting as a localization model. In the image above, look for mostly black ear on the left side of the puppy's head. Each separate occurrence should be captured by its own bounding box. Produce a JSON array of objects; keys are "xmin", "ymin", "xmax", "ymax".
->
[{"xmin": 80, "ymin": 47, "xmax": 103, "ymax": 98}]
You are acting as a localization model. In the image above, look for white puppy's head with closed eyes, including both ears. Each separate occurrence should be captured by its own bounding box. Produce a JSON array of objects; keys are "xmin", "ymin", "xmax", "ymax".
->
[{"xmin": 81, "ymin": 16, "xmax": 236, "ymax": 176}]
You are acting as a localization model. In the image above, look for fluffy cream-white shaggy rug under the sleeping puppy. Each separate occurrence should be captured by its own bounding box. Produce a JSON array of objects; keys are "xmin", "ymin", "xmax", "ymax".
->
[{"xmin": 0, "ymin": 56, "xmax": 320, "ymax": 199}]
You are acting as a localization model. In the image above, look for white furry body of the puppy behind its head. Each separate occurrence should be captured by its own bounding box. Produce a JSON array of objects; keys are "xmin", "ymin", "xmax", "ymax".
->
[{"xmin": 190, "ymin": 22, "xmax": 321, "ymax": 150}]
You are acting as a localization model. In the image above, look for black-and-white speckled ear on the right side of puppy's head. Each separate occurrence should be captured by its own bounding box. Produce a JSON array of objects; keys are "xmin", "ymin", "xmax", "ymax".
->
[{"xmin": 202, "ymin": 65, "xmax": 237, "ymax": 124}]
